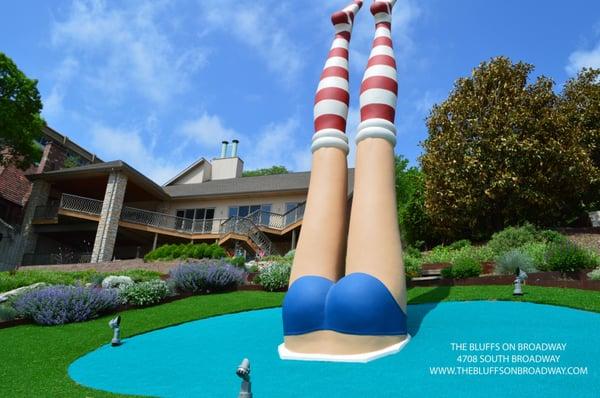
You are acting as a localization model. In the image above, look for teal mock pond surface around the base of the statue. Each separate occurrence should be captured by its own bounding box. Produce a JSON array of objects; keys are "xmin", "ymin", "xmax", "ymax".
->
[{"xmin": 69, "ymin": 301, "xmax": 600, "ymax": 398}]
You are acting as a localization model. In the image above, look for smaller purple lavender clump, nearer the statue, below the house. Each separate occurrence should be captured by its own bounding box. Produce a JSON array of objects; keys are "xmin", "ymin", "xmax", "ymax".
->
[{"xmin": 169, "ymin": 260, "xmax": 244, "ymax": 293}]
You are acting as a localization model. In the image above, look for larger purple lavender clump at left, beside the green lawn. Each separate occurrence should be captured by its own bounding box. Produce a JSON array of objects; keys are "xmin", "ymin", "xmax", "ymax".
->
[{"xmin": 14, "ymin": 285, "xmax": 119, "ymax": 325}]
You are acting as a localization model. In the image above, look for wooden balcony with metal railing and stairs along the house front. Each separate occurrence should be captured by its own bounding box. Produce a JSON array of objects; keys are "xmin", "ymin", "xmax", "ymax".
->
[{"xmin": 34, "ymin": 193, "xmax": 304, "ymax": 256}]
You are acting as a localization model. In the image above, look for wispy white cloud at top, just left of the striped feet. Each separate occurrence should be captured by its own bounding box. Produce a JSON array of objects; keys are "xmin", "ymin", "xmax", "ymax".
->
[{"xmin": 198, "ymin": 0, "xmax": 304, "ymax": 84}]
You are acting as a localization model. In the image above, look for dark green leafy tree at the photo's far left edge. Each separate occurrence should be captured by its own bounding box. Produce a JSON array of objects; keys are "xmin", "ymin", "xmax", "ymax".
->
[{"xmin": 0, "ymin": 52, "xmax": 44, "ymax": 169}]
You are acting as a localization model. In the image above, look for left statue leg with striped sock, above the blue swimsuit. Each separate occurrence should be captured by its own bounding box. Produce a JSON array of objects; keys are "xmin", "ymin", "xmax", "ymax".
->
[{"xmin": 290, "ymin": 1, "xmax": 362, "ymax": 285}]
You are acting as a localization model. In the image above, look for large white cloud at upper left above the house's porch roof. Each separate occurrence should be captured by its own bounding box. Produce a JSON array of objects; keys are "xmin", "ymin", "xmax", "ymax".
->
[{"xmin": 52, "ymin": 0, "xmax": 206, "ymax": 103}]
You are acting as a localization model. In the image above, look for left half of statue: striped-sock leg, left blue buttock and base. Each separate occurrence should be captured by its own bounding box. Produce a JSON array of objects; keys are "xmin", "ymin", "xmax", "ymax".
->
[{"xmin": 279, "ymin": 0, "xmax": 362, "ymax": 354}]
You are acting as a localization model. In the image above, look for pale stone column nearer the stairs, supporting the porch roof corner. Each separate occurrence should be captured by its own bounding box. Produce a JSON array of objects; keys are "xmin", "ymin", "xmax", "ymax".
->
[{"xmin": 91, "ymin": 172, "xmax": 127, "ymax": 263}]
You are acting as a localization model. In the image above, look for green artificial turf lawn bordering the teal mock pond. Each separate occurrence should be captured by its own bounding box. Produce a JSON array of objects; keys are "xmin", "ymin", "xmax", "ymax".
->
[{"xmin": 0, "ymin": 286, "xmax": 600, "ymax": 397}]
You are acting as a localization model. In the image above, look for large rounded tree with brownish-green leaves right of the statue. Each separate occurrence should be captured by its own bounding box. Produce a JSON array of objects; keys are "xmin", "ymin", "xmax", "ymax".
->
[{"xmin": 421, "ymin": 57, "xmax": 597, "ymax": 239}]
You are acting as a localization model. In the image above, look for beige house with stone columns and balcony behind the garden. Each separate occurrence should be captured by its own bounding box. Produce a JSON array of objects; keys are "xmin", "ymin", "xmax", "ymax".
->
[{"xmin": 22, "ymin": 140, "xmax": 353, "ymax": 265}]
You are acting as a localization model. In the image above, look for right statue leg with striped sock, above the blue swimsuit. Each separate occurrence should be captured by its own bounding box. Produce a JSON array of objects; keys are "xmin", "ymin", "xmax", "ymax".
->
[{"xmin": 346, "ymin": 0, "xmax": 406, "ymax": 313}]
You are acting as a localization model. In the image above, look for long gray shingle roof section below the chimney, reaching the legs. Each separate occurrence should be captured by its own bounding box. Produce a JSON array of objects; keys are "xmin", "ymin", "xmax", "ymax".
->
[{"xmin": 163, "ymin": 169, "xmax": 354, "ymax": 198}]
